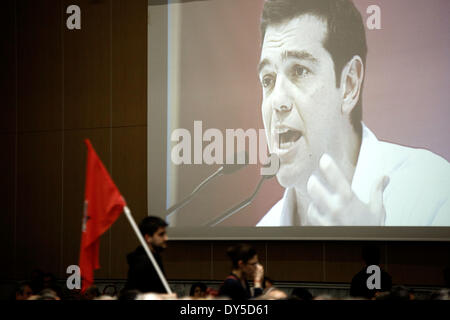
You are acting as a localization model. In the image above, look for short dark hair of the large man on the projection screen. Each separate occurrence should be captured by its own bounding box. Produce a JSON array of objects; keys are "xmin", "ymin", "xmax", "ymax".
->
[{"xmin": 261, "ymin": 0, "xmax": 367, "ymax": 133}]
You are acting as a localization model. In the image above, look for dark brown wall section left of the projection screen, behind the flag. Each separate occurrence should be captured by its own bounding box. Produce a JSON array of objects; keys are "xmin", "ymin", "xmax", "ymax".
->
[{"xmin": 0, "ymin": 0, "xmax": 147, "ymax": 279}]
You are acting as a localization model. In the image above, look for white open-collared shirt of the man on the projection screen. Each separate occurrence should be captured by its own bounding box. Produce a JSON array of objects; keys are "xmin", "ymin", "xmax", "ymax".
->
[{"xmin": 257, "ymin": 124, "xmax": 450, "ymax": 227}]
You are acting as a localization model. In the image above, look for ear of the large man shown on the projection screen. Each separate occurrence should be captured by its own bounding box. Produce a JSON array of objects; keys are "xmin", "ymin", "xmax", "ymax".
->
[{"xmin": 341, "ymin": 56, "xmax": 364, "ymax": 114}]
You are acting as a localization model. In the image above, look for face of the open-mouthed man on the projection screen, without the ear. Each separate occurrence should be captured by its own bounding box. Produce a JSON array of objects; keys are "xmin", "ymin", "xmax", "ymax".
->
[{"xmin": 259, "ymin": 15, "xmax": 342, "ymax": 188}]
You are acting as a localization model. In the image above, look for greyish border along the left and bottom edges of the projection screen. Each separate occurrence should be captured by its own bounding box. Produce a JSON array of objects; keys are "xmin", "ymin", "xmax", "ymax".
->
[{"xmin": 147, "ymin": 0, "xmax": 450, "ymax": 242}]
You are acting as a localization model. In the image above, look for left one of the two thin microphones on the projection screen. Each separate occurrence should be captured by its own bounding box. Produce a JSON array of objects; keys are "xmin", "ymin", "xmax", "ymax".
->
[{"xmin": 164, "ymin": 151, "xmax": 249, "ymax": 227}]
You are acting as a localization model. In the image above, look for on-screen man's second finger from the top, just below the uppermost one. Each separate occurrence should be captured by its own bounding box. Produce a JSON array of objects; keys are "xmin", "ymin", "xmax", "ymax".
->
[{"xmin": 306, "ymin": 175, "xmax": 339, "ymax": 213}]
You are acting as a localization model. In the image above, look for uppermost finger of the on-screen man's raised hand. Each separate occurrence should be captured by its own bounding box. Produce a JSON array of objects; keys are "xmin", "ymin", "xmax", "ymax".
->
[{"xmin": 319, "ymin": 153, "xmax": 352, "ymax": 199}]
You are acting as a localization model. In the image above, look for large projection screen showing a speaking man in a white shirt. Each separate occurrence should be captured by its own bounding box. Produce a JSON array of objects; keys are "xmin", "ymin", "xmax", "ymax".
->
[{"xmin": 147, "ymin": 0, "xmax": 450, "ymax": 241}]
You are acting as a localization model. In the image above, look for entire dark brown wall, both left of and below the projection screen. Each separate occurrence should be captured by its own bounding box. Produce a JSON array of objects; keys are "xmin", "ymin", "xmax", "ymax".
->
[{"xmin": 0, "ymin": 0, "xmax": 450, "ymax": 285}]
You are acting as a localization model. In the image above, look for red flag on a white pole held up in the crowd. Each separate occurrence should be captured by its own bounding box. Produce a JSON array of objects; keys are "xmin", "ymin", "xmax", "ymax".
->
[{"xmin": 79, "ymin": 139, "xmax": 126, "ymax": 292}]
